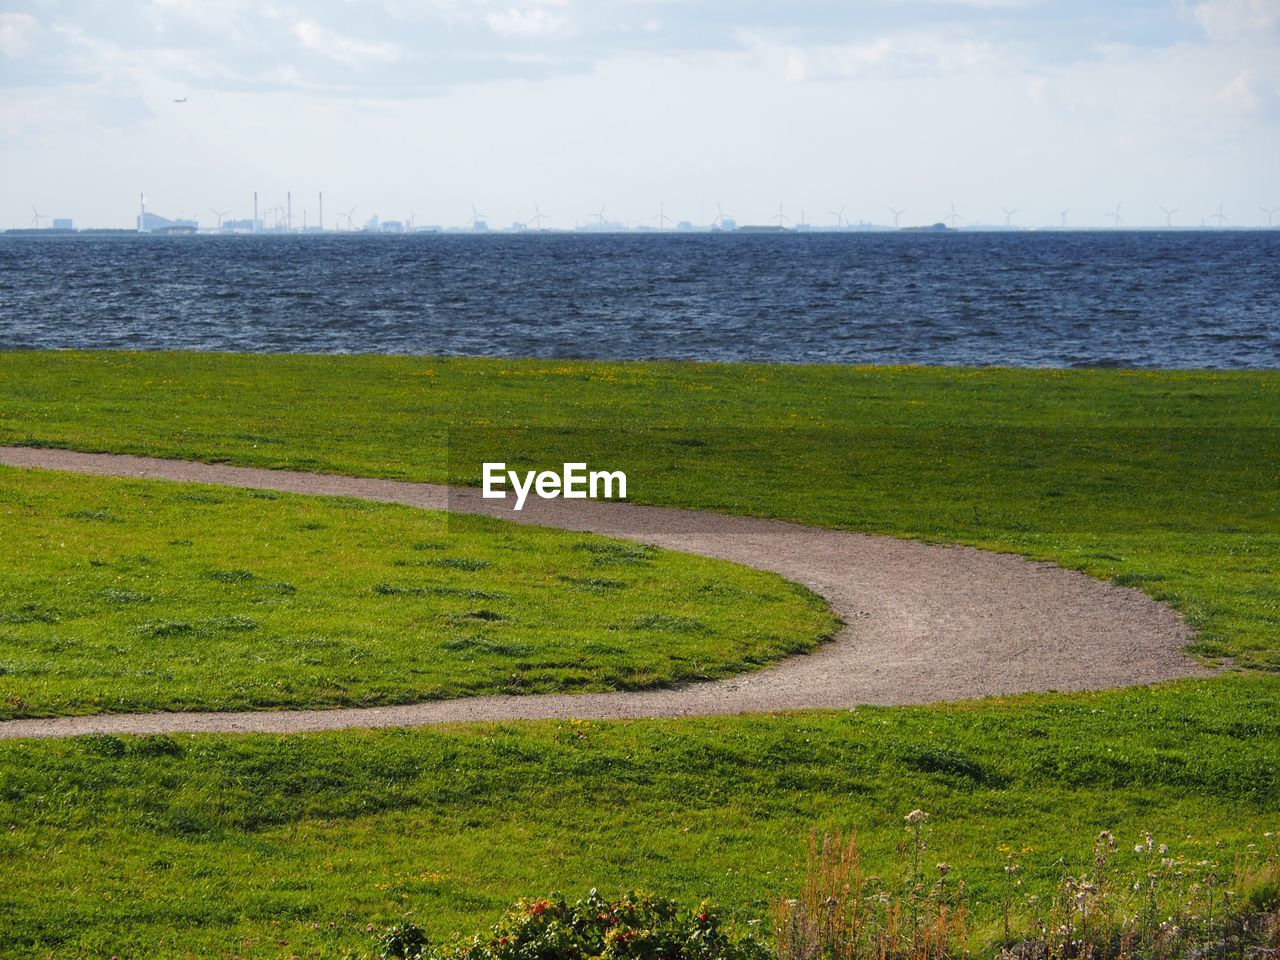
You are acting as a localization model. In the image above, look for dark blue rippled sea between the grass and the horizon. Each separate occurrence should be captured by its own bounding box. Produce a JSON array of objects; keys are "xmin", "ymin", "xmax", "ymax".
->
[{"xmin": 0, "ymin": 230, "xmax": 1280, "ymax": 367}]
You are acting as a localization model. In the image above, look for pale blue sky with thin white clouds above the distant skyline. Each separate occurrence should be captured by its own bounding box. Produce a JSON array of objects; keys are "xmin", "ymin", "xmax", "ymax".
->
[{"xmin": 0, "ymin": 0, "xmax": 1280, "ymax": 228}]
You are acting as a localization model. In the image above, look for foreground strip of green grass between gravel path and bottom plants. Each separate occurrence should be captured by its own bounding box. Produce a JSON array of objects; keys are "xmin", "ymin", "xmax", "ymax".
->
[{"xmin": 0, "ymin": 678, "xmax": 1280, "ymax": 957}]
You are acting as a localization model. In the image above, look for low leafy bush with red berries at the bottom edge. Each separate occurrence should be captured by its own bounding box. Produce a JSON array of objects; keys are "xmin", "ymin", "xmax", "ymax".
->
[{"xmin": 379, "ymin": 890, "xmax": 771, "ymax": 960}]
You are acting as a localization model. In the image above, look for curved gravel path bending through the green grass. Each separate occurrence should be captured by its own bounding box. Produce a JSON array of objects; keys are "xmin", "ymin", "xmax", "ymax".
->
[{"xmin": 0, "ymin": 447, "xmax": 1207, "ymax": 739}]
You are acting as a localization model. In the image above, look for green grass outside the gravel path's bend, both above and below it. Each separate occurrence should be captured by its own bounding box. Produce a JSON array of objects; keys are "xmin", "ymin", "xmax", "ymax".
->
[{"xmin": 0, "ymin": 353, "xmax": 1280, "ymax": 956}]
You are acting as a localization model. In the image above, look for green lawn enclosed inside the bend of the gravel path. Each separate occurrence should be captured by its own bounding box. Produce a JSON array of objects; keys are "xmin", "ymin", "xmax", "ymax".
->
[{"xmin": 0, "ymin": 467, "xmax": 836, "ymax": 718}]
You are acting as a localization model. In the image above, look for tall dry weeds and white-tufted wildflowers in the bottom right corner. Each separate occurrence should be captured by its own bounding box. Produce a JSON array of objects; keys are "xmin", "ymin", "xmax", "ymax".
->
[{"xmin": 773, "ymin": 824, "xmax": 1280, "ymax": 960}]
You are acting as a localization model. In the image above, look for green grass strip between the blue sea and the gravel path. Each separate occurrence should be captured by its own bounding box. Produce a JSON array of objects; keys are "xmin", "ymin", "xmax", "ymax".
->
[{"xmin": 0, "ymin": 352, "xmax": 1280, "ymax": 669}]
